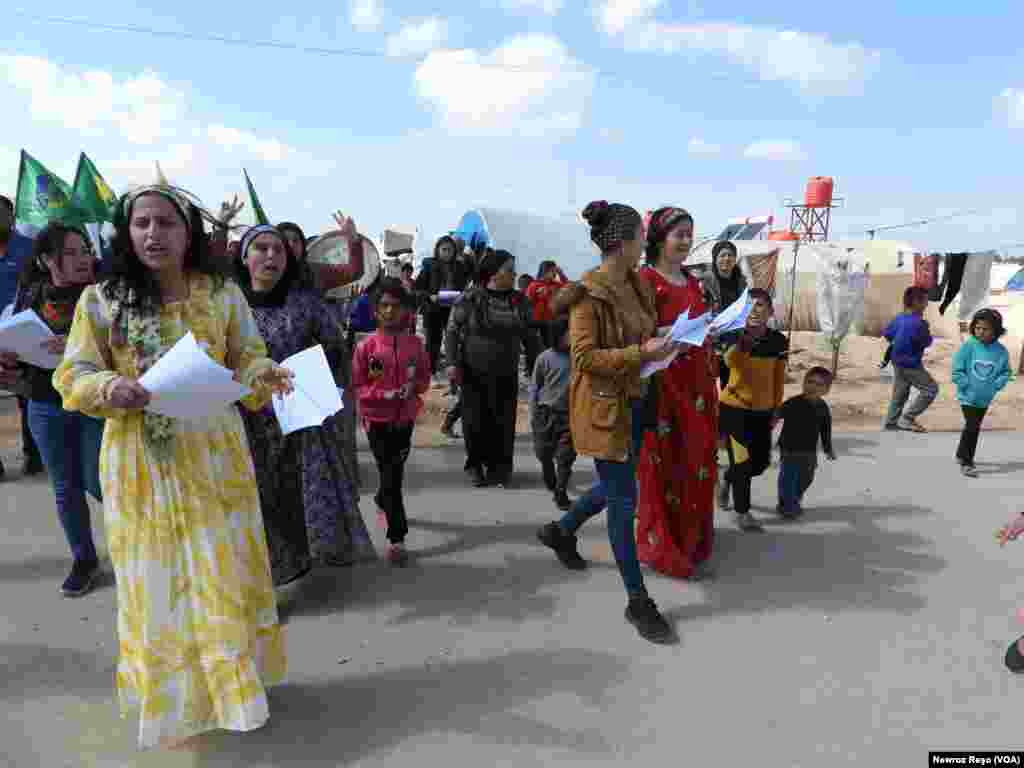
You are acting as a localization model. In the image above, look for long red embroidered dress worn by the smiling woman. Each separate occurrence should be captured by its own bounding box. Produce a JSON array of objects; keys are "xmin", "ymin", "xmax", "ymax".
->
[{"xmin": 636, "ymin": 267, "xmax": 718, "ymax": 579}]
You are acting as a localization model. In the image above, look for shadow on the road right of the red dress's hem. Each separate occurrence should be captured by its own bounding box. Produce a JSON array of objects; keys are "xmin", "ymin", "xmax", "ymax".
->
[{"xmin": 673, "ymin": 505, "xmax": 946, "ymax": 622}]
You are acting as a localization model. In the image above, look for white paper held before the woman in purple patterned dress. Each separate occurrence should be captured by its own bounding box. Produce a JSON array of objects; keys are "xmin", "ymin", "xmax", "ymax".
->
[{"xmin": 273, "ymin": 344, "xmax": 344, "ymax": 434}]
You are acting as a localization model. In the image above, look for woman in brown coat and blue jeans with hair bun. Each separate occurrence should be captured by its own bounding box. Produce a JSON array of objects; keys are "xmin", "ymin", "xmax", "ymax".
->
[{"xmin": 538, "ymin": 201, "xmax": 673, "ymax": 642}]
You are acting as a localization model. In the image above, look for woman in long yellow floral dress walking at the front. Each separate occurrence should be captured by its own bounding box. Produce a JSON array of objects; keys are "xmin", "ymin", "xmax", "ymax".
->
[{"xmin": 53, "ymin": 182, "xmax": 291, "ymax": 749}]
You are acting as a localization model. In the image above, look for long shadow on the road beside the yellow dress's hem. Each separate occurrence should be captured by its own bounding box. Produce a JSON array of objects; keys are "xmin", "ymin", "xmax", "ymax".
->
[{"xmin": 191, "ymin": 649, "xmax": 629, "ymax": 768}]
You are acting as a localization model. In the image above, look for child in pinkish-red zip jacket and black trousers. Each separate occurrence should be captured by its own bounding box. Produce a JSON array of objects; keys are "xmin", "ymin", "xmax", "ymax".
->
[{"xmin": 352, "ymin": 278, "xmax": 430, "ymax": 565}]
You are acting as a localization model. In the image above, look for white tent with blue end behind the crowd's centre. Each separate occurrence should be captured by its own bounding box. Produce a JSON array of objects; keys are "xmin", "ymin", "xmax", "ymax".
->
[{"xmin": 456, "ymin": 208, "xmax": 600, "ymax": 280}]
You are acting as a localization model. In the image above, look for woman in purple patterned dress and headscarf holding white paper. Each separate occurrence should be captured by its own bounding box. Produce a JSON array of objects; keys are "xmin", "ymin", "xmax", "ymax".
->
[{"xmin": 237, "ymin": 225, "xmax": 376, "ymax": 587}]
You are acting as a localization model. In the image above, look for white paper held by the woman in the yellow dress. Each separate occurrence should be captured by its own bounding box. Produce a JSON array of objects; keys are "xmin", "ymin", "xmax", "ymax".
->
[{"xmin": 138, "ymin": 332, "xmax": 252, "ymax": 422}]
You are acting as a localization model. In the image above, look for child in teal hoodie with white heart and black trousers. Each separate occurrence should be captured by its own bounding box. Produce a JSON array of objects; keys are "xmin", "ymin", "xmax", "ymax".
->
[{"xmin": 953, "ymin": 309, "xmax": 1010, "ymax": 477}]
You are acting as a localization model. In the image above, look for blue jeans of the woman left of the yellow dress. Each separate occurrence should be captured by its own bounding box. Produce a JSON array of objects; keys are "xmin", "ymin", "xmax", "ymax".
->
[{"xmin": 29, "ymin": 400, "xmax": 103, "ymax": 562}]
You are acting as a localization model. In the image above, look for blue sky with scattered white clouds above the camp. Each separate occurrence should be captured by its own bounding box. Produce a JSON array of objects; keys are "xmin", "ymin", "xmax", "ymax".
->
[{"xmin": 0, "ymin": 0, "xmax": 1024, "ymax": 254}]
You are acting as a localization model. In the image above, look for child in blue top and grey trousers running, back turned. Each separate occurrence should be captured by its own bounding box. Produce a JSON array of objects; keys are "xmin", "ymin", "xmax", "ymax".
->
[{"xmin": 882, "ymin": 286, "xmax": 939, "ymax": 432}]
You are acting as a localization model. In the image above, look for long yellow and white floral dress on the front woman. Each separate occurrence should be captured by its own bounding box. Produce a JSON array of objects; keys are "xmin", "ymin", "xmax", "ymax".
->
[{"xmin": 53, "ymin": 275, "xmax": 286, "ymax": 748}]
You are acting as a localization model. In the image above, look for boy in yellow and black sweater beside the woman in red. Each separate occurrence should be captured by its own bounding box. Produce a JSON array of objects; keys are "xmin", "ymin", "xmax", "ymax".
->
[{"xmin": 719, "ymin": 288, "xmax": 790, "ymax": 530}]
